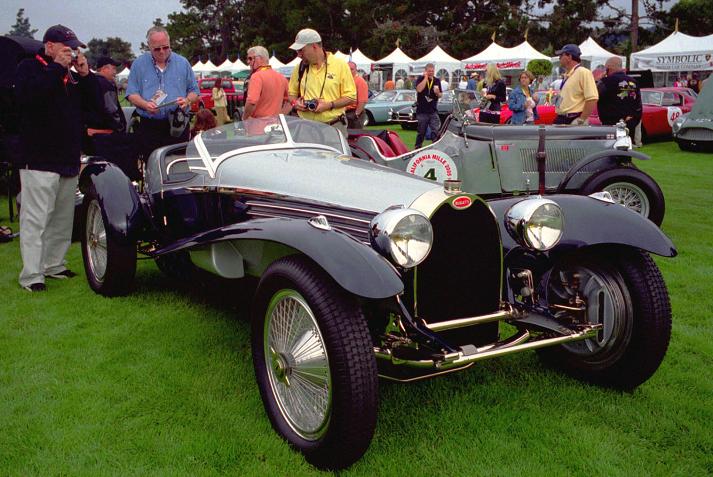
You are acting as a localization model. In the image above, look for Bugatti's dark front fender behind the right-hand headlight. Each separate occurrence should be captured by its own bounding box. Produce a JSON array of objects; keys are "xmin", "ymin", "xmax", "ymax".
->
[{"xmin": 488, "ymin": 194, "xmax": 678, "ymax": 257}]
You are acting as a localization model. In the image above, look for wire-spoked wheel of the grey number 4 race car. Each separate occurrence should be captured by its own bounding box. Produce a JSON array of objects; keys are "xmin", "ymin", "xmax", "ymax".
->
[{"xmin": 580, "ymin": 167, "xmax": 666, "ymax": 226}]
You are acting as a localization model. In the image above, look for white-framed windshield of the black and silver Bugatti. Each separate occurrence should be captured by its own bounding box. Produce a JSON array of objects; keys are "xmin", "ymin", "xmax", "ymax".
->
[{"xmin": 186, "ymin": 115, "xmax": 348, "ymax": 176}]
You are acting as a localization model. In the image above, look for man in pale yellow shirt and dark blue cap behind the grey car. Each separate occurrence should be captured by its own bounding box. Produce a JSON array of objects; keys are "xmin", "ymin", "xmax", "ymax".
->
[{"xmin": 555, "ymin": 44, "xmax": 599, "ymax": 125}]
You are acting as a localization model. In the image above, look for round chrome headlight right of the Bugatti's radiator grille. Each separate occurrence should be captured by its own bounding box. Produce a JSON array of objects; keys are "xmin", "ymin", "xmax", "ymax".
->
[{"xmin": 505, "ymin": 196, "xmax": 564, "ymax": 251}]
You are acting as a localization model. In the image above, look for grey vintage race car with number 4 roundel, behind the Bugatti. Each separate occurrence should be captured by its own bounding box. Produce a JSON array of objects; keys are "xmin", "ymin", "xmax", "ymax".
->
[{"xmin": 350, "ymin": 95, "xmax": 666, "ymax": 225}]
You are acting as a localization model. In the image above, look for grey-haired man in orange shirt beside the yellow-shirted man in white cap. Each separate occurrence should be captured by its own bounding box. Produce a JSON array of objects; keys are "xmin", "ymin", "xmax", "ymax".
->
[{"xmin": 243, "ymin": 46, "xmax": 292, "ymax": 121}]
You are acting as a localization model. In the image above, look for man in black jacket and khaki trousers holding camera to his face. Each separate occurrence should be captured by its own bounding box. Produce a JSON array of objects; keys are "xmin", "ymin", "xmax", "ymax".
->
[{"xmin": 15, "ymin": 25, "xmax": 95, "ymax": 292}]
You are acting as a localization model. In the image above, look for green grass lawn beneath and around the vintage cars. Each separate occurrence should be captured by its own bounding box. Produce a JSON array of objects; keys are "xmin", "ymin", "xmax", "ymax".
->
[{"xmin": 0, "ymin": 139, "xmax": 713, "ymax": 476}]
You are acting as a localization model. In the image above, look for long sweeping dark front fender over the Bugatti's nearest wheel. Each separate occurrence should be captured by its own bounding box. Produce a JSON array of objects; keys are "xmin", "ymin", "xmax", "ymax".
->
[{"xmin": 155, "ymin": 218, "xmax": 404, "ymax": 299}]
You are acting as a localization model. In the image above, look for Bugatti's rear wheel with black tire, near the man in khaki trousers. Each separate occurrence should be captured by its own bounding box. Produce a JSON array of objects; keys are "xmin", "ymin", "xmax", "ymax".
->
[{"xmin": 81, "ymin": 185, "xmax": 136, "ymax": 296}]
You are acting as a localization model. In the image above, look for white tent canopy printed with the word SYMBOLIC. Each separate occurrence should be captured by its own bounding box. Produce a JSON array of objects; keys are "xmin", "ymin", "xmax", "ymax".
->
[{"xmin": 631, "ymin": 31, "xmax": 713, "ymax": 71}]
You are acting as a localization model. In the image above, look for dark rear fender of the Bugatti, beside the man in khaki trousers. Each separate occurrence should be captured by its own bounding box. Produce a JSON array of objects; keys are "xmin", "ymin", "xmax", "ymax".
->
[{"xmin": 79, "ymin": 162, "xmax": 147, "ymax": 245}]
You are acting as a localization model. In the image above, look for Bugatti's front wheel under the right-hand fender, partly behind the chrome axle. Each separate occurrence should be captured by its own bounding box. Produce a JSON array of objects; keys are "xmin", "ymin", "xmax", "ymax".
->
[{"xmin": 540, "ymin": 249, "xmax": 671, "ymax": 390}]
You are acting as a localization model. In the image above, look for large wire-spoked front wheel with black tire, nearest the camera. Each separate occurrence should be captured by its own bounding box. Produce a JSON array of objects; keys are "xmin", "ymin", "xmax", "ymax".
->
[{"xmin": 252, "ymin": 256, "xmax": 378, "ymax": 469}]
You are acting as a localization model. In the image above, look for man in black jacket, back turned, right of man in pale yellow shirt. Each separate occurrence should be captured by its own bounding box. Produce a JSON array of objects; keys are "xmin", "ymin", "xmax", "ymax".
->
[{"xmin": 597, "ymin": 56, "xmax": 642, "ymax": 134}]
